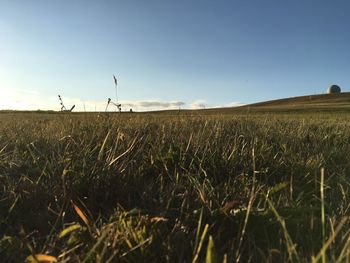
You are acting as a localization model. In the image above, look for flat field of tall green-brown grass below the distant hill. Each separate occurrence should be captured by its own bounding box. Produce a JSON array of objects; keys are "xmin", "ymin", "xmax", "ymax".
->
[{"xmin": 0, "ymin": 106, "xmax": 350, "ymax": 262}]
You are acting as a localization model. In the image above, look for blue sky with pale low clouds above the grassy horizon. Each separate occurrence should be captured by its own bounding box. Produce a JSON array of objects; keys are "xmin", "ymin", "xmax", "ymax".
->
[{"xmin": 0, "ymin": 0, "xmax": 350, "ymax": 110}]
